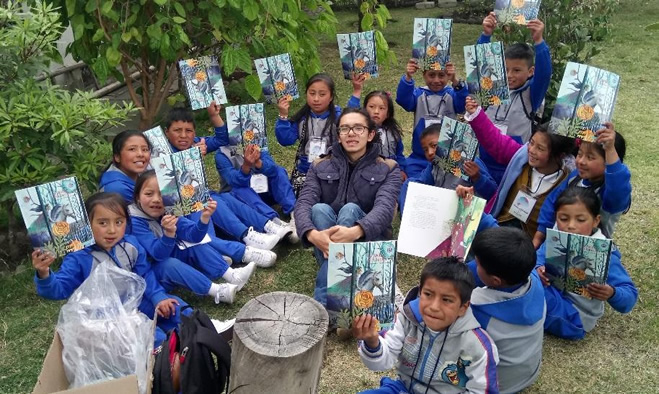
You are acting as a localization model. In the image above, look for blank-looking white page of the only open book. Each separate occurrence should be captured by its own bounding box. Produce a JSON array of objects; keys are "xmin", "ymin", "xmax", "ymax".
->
[{"xmin": 398, "ymin": 182, "xmax": 458, "ymax": 257}]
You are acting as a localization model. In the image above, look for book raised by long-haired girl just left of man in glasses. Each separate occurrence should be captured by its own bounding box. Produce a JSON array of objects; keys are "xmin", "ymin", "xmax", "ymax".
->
[{"xmin": 254, "ymin": 53, "xmax": 300, "ymax": 104}]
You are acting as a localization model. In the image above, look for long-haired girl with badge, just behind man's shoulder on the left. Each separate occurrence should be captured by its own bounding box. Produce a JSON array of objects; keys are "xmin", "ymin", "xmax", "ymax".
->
[{"xmin": 275, "ymin": 73, "xmax": 356, "ymax": 197}]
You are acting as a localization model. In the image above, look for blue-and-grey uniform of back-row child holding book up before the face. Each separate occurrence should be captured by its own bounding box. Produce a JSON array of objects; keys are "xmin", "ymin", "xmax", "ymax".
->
[{"xmin": 396, "ymin": 75, "xmax": 469, "ymax": 177}]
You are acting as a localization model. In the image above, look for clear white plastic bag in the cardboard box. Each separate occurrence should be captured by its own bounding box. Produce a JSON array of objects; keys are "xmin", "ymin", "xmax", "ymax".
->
[{"xmin": 57, "ymin": 262, "xmax": 153, "ymax": 393}]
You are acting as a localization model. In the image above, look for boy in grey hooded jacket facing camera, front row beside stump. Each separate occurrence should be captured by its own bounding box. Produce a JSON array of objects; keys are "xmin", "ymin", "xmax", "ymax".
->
[{"xmin": 352, "ymin": 257, "xmax": 499, "ymax": 394}]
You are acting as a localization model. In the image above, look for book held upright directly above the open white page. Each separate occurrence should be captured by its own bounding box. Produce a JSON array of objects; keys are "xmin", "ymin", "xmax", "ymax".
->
[{"xmin": 435, "ymin": 116, "xmax": 478, "ymax": 181}]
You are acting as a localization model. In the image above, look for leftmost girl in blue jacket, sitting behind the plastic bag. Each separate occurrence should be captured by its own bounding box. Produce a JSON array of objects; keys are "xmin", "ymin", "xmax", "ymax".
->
[{"xmin": 32, "ymin": 193, "xmax": 186, "ymax": 343}]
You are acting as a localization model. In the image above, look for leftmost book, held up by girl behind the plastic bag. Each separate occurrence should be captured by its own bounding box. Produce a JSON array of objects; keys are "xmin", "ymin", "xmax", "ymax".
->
[{"xmin": 14, "ymin": 177, "xmax": 96, "ymax": 257}]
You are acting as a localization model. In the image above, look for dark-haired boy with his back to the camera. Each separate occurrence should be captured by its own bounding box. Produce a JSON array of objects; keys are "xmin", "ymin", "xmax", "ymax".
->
[{"xmin": 469, "ymin": 227, "xmax": 546, "ymax": 393}]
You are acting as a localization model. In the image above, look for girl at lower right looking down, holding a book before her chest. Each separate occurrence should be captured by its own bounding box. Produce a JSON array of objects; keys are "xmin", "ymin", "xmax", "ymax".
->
[{"xmin": 536, "ymin": 187, "xmax": 638, "ymax": 339}]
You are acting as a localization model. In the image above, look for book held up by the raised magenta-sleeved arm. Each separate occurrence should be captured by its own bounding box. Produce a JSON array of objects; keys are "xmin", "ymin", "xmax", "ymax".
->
[{"xmin": 464, "ymin": 42, "xmax": 510, "ymax": 107}]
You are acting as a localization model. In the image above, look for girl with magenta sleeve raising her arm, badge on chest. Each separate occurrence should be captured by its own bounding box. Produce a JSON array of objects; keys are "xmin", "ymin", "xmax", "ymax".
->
[{"xmin": 465, "ymin": 97, "xmax": 571, "ymax": 237}]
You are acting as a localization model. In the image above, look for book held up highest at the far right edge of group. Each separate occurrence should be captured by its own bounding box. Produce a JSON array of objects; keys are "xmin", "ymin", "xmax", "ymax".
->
[{"xmin": 549, "ymin": 62, "xmax": 620, "ymax": 142}]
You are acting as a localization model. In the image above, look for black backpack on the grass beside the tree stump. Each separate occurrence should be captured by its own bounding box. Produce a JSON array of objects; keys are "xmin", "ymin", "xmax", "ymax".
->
[{"xmin": 151, "ymin": 307, "xmax": 231, "ymax": 394}]
